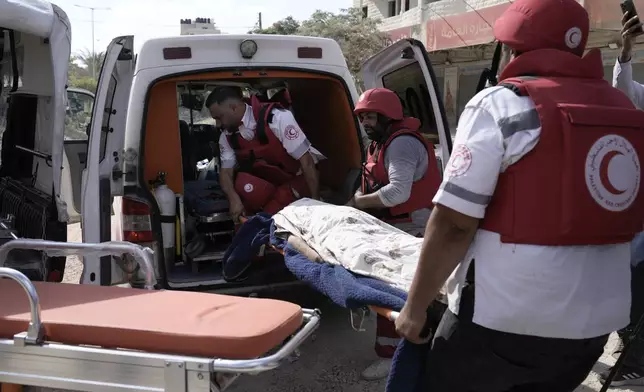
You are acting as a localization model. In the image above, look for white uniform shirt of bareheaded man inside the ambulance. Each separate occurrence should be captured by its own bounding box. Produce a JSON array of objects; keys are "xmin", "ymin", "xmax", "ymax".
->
[{"xmin": 219, "ymin": 105, "xmax": 325, "ymax": 169}]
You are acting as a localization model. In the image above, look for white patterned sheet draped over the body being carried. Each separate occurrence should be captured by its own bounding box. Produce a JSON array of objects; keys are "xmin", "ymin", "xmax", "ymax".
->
[{"xmin": 273, "ymin": 198, "xmax": 423, "ymax": 291}]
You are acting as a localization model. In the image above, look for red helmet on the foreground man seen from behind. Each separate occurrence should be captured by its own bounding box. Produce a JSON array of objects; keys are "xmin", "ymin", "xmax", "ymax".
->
[{"xmin": 494, "ymin": 0, "xmax": 590, "ymax": 56}]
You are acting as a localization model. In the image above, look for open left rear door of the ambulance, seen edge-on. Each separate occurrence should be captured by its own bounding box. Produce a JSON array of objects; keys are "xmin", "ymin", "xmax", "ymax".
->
[{"xmin": 81, "ymin": 35, "xmax": 134, "ymax": 286}]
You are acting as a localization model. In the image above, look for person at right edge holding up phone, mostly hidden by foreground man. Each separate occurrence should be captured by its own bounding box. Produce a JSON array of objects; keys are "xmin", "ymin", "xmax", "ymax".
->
[{"xmin": 600, "ymin": 14, "xmax": 644, "ymax": 387}]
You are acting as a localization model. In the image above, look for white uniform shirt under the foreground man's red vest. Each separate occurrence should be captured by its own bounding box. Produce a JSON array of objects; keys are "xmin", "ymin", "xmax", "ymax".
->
[{"xmin": 434, "ymin": 87, "xmax": 631, "ymax": 339}]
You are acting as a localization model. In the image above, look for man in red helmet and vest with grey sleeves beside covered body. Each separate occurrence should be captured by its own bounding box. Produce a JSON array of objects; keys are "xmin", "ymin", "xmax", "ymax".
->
[{"xmin": 348, "ymin": 88, "xmax": 440, "ymax": 380}]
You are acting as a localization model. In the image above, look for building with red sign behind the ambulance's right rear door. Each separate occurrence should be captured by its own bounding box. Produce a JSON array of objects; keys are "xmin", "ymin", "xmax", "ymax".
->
[{"xmin": 353, "ymin": 0, "xmax": 644, "ymax": 129}]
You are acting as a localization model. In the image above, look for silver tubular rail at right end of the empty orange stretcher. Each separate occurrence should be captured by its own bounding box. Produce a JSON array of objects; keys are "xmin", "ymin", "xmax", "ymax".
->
[{"xmin": 211, "ymin": 309, "xmax": 321, "ymax": 373}]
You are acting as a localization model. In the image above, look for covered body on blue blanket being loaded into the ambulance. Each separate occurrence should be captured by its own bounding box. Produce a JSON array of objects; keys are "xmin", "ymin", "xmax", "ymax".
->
[{"xmin": 224, "ymin": 199, "xmax": 443, "ymax": 392}]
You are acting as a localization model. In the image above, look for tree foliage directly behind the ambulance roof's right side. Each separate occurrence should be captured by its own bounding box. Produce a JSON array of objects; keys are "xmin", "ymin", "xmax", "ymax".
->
[{"xmin": 251, "ymin": 8, "xmax": 387, "ymax": 85}]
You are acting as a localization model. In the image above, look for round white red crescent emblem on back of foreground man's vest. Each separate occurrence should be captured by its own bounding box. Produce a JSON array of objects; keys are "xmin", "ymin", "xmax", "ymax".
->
[{"xmin": 586, "ymin": 135, "xmax": 641, "ymax": 212}]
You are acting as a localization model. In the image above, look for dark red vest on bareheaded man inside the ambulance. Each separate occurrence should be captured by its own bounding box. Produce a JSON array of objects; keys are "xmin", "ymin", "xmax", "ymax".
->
[{"xmin": 226, "ymin": 96, "xmax": 301, "ymax": 186}]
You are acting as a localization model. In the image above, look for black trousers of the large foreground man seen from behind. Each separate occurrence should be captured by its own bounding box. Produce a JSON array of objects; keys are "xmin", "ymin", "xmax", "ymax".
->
[{"xmin": 428, "ymin": 285, "xmax": 608, "ymax": 392}]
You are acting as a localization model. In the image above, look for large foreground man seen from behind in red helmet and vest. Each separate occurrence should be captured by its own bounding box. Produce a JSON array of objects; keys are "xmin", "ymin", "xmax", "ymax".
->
[{"xmin": 396, "ymin": 0, "xmax": 644, "ymax": 392}]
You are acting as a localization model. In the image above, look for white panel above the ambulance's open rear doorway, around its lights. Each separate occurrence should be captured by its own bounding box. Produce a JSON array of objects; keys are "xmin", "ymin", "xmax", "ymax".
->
[{"xmin": 136, "ymin": 34, "xmax": 347, "ymax": 71}]
